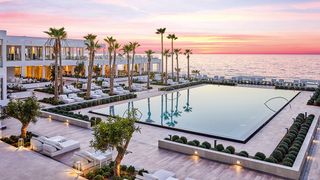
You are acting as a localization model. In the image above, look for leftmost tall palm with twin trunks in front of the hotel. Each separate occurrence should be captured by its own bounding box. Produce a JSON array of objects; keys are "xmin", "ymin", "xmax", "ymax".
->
[{"xmin": 44, "ymin": 27, "xmax": 67, "ymax": 101}]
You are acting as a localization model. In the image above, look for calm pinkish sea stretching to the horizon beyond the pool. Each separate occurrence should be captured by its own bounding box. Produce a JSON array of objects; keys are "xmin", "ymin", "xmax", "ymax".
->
[{"xmin": 156, "ymin": 54, "xmax": 320, "ymax": 80}]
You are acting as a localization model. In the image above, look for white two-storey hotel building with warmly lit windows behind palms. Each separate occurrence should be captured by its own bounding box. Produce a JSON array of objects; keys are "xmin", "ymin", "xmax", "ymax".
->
[{"xmin": 0, "ymin": 30, "xmax": 161, "ymax": 106}]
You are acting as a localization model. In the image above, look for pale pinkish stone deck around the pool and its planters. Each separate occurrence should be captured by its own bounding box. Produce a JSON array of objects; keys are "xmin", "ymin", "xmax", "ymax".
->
[{"xmin": 0, "ymin": 86, "xmax": 320, "ymax": 180}]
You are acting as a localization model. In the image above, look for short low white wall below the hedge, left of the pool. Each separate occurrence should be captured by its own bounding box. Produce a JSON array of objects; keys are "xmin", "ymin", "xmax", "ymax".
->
[{"xmin": 41, "ymin": 111, "xmax": 91, "ymax": 129}]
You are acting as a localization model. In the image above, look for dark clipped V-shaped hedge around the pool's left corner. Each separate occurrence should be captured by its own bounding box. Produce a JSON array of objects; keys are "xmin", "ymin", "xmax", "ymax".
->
[{"xmin": 43, "ymin": 94, "xmax": 137, "ymax": 125}]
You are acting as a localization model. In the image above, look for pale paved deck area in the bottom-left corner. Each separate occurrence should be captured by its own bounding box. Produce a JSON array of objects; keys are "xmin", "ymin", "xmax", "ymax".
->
[{"xmin": 0, "ymin": 141, "xmax": 84, "ymax": 180}]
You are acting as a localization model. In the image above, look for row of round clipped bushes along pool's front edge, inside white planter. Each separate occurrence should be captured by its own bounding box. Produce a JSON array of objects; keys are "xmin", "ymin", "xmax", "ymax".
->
[{"xmin": 165, "ymin": 135, "xmax": 266, "ymax": 160}]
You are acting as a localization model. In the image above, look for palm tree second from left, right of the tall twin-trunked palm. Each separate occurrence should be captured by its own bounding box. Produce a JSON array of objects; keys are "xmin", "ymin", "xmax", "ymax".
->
[{"xmin": 84, "ymin": 34, "xmax": 100, "ymax": 99}]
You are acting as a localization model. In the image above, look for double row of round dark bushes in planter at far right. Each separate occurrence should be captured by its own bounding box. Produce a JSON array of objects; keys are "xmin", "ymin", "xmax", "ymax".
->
[{"xmin": 266, "ymin": 113, "xmax": 315, "ymax": 167}]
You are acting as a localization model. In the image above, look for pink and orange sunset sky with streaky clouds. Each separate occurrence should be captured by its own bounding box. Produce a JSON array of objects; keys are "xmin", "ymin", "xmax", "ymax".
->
[{"xmin": 0, "ymin": 0, "xmax": 320, "ymax": 54}]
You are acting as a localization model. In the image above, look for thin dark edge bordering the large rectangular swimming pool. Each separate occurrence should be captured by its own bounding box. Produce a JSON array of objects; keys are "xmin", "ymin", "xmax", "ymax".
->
[{"xmin": 89, "ymin": 84, "xmax": 301, "ymax": 144}]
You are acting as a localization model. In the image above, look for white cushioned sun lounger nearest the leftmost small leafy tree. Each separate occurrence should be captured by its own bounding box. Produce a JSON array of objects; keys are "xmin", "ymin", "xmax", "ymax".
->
[{"xmin": 30, "ymin": 136, "xmax": 80, "ymax": 157}]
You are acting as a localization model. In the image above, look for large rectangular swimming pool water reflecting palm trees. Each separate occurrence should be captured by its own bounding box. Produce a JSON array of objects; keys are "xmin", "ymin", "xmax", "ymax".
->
[{"xmin": 92, "ymin": 85, "xmax": 299, "ymax": 143}]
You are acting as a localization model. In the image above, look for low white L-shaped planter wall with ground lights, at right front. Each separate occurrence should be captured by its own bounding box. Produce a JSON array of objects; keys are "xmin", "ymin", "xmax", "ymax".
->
[{"xmin": 158, "ymin": 117, "xmax": 320, "ymax": 179}]
